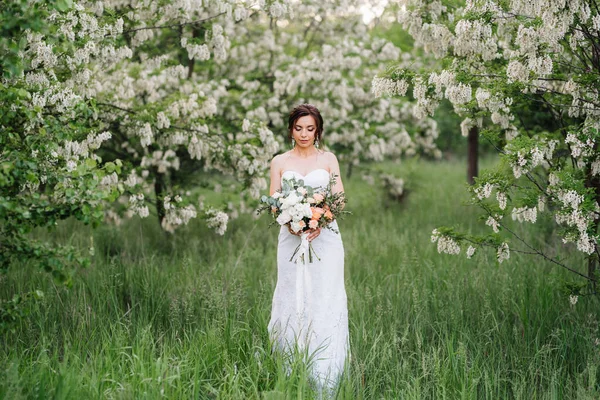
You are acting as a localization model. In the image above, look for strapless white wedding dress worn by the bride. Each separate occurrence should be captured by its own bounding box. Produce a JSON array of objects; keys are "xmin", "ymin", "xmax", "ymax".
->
[{"xmin": 268, "ymin": 169, "xmax": 349, "ymax": 388}]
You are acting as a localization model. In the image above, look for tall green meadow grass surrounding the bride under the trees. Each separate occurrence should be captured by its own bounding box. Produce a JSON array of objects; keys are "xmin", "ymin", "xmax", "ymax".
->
[{"xmin": 0, "ymin": 161, "xmax": 600, "ymax": 399}]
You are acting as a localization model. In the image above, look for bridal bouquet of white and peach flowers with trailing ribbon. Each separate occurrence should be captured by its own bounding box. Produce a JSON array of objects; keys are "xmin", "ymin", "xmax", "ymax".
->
[{"xmin": 257, "ymin": 175, "xmax": 348, "ymax": 264}]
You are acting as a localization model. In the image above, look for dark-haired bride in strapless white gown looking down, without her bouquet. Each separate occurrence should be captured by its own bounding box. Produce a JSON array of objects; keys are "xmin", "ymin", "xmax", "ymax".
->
[{"xmin": 268, "ymin": 104, "xmax": 349, "ymax": 388}]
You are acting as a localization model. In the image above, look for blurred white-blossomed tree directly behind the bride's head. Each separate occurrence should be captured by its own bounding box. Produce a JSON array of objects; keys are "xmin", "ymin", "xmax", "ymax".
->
[{"xmin": 206, "ymin": 1, "xmax": 440, "ymax": 180}]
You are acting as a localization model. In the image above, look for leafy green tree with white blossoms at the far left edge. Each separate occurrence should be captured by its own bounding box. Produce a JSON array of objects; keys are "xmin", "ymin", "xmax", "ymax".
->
[{"xmin": 0, "ymin": 1, "xmax": 122, "ymax": 283}]
